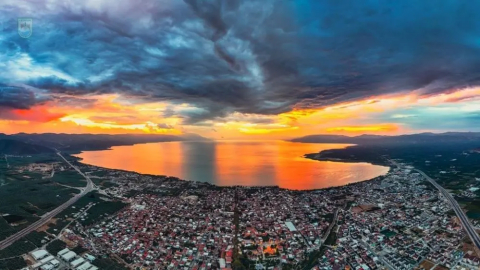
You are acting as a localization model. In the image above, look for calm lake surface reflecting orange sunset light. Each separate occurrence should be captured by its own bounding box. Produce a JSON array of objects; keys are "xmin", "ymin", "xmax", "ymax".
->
[{"xmin": 77, "ymin": 141, "xmax": 388, "ymax": 189}]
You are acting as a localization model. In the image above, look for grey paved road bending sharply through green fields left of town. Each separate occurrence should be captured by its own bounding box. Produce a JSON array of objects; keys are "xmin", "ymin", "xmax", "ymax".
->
[{"xmin": 0, "ymin": 152, "xmax": 94, "ymax": 250}]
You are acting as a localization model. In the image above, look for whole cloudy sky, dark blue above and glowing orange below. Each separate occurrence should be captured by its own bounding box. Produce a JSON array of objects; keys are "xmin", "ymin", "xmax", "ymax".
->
[{"xmin": 0, "ymin": 0, "xmax": 480, "ymax": 139}]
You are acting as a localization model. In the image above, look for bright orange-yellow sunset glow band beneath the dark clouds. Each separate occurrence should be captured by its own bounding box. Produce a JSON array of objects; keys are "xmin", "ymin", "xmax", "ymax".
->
[{"xmin": 0, "ymin": 88, "xmax": 480, "ymax": 139}]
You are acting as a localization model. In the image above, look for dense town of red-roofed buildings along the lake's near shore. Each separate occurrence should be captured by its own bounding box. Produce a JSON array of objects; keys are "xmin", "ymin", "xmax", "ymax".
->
[{"xmin": 1, "ymin": 157, "xmax": 480, "ymax": 270}]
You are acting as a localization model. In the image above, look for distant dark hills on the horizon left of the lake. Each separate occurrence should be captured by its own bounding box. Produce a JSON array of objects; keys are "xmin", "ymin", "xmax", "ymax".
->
[{"xmin": 0, "ymin": 133, "xmax": 208, "ymax": 151}]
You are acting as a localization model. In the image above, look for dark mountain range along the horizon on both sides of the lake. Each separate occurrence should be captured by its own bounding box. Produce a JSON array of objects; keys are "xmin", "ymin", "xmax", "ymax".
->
[{"xmin": 0, "ymin": 132, "xmax": 480, "ymax": 155}]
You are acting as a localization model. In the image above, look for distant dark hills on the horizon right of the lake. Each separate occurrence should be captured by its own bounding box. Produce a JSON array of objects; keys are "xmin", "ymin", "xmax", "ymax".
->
[{"xmin": 290, "ymin": 132, "xmax": 480, "ymax": 144}]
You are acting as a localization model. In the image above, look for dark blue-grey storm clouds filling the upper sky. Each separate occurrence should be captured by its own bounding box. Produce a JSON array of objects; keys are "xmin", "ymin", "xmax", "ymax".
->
[{"xmin": 0, "ymin": 0, "xmax": 480, "ymax": 124}]
